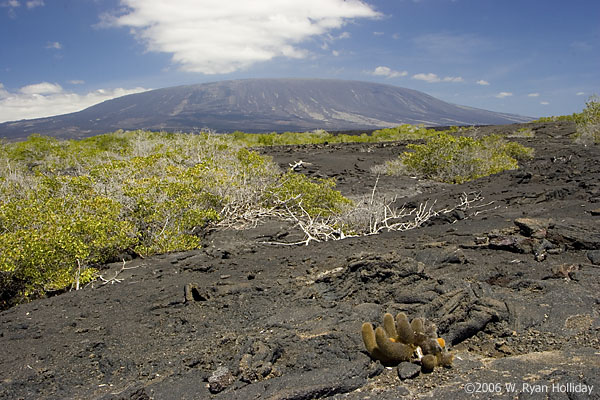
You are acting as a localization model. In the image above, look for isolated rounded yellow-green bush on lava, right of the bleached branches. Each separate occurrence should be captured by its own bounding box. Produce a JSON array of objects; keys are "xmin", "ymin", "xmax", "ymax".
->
[{"xmin": 392, "ymin": 132, "xmax": 532, "ymax": 183}]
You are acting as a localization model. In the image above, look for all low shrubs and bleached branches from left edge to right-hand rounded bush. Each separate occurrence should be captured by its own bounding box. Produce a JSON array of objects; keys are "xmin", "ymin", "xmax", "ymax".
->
[{"xmin": 0, "ymin": 120, "xmax": 530, "ymax": 308}]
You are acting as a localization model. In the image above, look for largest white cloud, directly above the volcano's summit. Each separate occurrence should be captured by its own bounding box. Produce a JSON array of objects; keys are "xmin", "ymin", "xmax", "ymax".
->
[{"xmin": 103, "ymin": 0, "xmax": 380, "ymax": 74}]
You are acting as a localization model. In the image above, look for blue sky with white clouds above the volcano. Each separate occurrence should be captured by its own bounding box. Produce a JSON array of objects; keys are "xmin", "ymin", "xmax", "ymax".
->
[{"xmin": 0, "ymin": 0, "xmax": 600, "ymax": 122}]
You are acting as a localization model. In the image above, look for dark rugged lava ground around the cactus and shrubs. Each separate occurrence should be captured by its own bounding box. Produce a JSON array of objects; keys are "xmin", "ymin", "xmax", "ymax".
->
[{"xmin": 0, "ymin": 120, "xmax": 600, "ymax": 399}]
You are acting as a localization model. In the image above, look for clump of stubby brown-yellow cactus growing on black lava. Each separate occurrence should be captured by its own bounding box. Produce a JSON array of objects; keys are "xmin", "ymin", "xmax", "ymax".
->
[{"xmin": 362, "ymin": 313, "xmax": 454, "ymax": 372}]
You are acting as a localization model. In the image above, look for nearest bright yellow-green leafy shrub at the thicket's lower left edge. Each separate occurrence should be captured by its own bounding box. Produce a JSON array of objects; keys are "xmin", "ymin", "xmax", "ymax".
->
[{"xmin": 0, "ymin": 177, "xmax": 134, "ymax": 306}]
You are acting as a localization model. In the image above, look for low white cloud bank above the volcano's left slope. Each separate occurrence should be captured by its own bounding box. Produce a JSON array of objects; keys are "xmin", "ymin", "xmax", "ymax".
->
[{"xmin": 0, "ymin": 82, "xmax": 148, "ymax": 122}]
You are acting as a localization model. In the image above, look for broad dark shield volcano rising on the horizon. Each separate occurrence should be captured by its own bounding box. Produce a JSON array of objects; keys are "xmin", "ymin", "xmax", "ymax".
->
[{"xmin": 0, "ymin": 79, "xmax": 531, "ymax": 139}]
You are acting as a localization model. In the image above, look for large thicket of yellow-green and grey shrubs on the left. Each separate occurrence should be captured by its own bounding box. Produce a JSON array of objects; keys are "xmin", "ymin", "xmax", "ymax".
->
[{"xmin": 0, "ymin": 131, "xmax": 349, "ymax": 308}]
